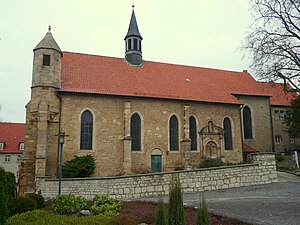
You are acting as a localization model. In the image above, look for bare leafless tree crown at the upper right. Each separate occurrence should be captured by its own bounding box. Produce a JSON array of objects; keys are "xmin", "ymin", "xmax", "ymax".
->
[{"xmin": 244, "ymin": 0, "xmax": 300, "ymax": 93}]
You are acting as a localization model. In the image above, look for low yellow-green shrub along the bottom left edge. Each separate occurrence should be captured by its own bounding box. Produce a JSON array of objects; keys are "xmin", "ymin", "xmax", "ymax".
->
[{"xmin": 7, "ymin": 210, "xmax": 112, "ymax": 225}]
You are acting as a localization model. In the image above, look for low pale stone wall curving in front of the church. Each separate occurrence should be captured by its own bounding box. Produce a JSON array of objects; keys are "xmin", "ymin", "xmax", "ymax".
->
[{"xmin": 36, "ymin": 153, "xmax": 277, "ymax": 200}]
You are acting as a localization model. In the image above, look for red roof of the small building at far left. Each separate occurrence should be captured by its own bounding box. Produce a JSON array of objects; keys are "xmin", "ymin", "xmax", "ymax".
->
[{"xmin": 0, "ymin": 122, "xmax": 25, "ymax": 154}]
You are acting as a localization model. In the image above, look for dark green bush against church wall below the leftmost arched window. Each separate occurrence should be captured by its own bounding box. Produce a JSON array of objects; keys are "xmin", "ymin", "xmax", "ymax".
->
[{"xmin": 62, "ymin": 155, "xmax": 96, "ymax": 177}]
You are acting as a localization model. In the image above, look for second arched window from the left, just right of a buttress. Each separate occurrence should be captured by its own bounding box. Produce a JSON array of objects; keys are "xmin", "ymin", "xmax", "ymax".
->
[{"xmin": 130, "ymin": 113, "xmax": 141, "ymax": 151}]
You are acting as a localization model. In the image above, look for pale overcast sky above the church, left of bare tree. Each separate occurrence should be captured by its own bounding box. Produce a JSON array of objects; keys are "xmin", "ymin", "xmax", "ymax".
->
[{"xmin": 0, "ymin": 0, "xmax": 252, "ymax": 122}]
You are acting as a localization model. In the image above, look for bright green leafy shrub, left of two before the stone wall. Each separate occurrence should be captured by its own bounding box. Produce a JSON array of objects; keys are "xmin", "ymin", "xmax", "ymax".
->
[{"xmin": 52, "ymin": 194, "xmax": 87, "ymax": 215}]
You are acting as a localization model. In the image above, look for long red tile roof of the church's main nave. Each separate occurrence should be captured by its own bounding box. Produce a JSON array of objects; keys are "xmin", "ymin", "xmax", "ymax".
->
[{"xmin": 61, "ymin": 52, "xmax": 296, "ymax": 104}]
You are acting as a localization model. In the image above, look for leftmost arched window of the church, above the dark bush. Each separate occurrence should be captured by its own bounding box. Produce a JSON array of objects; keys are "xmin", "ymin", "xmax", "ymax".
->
[{"xmin": 80, "ymin": 110, "xmax": 93, "ymax": 150}]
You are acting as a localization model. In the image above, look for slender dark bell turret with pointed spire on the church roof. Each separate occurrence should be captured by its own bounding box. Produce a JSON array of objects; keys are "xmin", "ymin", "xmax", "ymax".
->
[{"xmin": 124, "ymin": 5, "xmax": 143, "ymax": 66}]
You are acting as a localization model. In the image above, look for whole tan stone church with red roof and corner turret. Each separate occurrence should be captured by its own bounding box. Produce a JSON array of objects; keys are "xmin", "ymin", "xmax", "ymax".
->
[{"xmin": 23, "ymin": 8, "xmax": 297, "ymax": 192}]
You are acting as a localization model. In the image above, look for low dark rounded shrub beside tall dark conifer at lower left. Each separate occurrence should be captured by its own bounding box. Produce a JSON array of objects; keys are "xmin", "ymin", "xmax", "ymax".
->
[{"xmin": 8, "ymin": 196, "xmax": 36, "ymax": 216}]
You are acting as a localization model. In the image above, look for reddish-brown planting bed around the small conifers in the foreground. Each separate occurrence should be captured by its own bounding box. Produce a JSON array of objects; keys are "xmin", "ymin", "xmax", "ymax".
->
[{"xmin": 43, "ymin": 201, "xmax": 251, "ymax": 225}]
